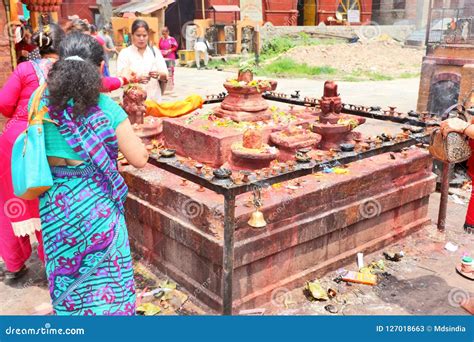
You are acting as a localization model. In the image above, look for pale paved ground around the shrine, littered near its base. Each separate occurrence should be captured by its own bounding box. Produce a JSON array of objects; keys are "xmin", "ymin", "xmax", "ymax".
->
[{"xmin": 0, "ymin": 68, "xmax": 474, "ymax": 315}]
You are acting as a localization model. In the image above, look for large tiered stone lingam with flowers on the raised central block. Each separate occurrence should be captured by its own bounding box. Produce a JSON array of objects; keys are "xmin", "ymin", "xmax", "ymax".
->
[{"xmin": 214, "ymin": 71, "xmax": 277, "ymax": 122}]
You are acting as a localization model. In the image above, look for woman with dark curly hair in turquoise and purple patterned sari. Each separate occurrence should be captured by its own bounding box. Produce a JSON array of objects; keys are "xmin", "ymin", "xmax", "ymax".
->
[{"xmin": 30, "ymin": 33, "xmax": 148, "ymax": 315}]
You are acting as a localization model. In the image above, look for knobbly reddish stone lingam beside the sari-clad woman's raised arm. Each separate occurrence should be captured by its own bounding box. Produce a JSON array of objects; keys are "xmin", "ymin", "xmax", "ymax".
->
[{"xmin": 121, "ymin": 85, "xmax": 162, "ymax": 143}]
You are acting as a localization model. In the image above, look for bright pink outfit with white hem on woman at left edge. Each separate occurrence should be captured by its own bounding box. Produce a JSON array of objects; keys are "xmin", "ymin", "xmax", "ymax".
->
[{"xmin": 0, "ymin": 61, "xmax": 51, "ymax": 272}]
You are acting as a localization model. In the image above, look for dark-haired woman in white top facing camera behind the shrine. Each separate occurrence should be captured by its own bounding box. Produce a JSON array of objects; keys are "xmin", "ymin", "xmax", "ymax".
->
[{"xmin": 117, "ymin": 19, "xmax": 168, "ymax": 102}]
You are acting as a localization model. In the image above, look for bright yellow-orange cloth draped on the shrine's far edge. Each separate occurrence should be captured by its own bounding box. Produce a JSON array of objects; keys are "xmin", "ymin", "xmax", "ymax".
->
[{"xmin": 145, "ymin": 95, "xmax": 204, "ymax": 118}]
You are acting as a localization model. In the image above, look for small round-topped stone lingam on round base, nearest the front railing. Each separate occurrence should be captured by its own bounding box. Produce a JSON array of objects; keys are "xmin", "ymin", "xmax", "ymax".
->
[{"xmin": 231, "ymin": 128, "xmax": 279, "ymax": 170}]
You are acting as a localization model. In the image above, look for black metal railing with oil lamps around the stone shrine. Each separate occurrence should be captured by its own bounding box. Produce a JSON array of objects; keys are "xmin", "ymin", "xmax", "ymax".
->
[{"xmin": 150, "ymin": 94, "xmax": 434, "ymax": 315}]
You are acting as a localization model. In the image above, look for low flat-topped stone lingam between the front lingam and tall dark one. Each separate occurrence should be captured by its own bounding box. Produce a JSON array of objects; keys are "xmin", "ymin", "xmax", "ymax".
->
[{"xmin": 270, "ymin": 125, "xmax": 322, "ymax": 161}]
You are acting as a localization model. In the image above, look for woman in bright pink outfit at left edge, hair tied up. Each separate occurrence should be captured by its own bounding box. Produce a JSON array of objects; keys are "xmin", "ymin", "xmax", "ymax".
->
[{"xmin": 0, "ymin": 24, "xmax": 64, "ymax": 281}]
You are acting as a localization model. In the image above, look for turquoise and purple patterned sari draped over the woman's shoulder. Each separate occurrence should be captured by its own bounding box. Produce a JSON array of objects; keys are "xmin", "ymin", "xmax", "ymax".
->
[{"xmin": 40, "ymin": 102, "xmax": 135, "ymax": 315}]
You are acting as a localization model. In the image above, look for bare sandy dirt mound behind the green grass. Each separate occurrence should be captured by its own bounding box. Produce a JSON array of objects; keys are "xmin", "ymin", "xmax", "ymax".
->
[{"xmin": 283, "ymin": 40, "xmax": 424, "ymax": 78}]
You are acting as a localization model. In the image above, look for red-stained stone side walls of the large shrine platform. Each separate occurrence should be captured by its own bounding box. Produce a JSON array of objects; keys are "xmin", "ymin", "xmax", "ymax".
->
[{"xmin": 123, "ymin": 149, "xmax": 435, "ymax": 312}]
